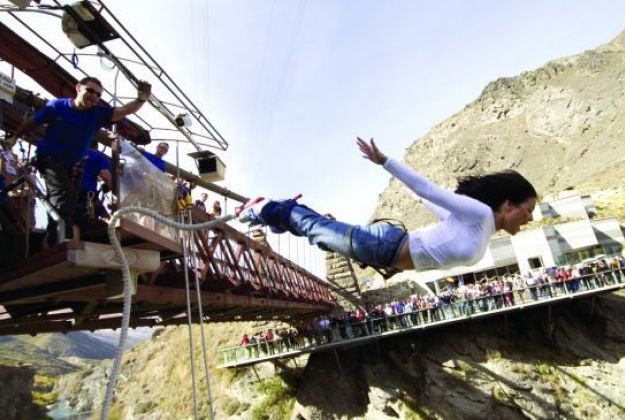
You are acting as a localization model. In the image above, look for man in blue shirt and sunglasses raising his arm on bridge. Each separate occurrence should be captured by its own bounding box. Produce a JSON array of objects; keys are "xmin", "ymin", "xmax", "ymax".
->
[{"xmin": 14, "ymin": 77, "xmax": 151, "ymax": 244}]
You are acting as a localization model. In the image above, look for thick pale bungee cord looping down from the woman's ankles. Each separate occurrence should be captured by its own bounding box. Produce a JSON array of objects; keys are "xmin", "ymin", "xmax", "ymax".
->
[{"xmin": 100, "ymin": 206, "xmax": 235, "ymax": 420}]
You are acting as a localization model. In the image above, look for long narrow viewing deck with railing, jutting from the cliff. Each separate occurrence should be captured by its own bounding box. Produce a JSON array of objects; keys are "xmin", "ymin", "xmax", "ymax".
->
[{"xmin": 218, "ymin": 271, "xmax": 625, "ymax": 368}]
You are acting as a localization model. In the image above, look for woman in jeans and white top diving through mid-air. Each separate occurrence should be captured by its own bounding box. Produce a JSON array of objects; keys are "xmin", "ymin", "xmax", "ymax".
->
[{"xmin": 239, "ymin": 138, "xmax": 537, "ymax": 271}]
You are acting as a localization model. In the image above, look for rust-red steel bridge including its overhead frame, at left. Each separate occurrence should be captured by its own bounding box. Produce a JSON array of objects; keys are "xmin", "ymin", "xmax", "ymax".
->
[{"xmin": 0, "ymin": 2, "xmax": 334, "ymax": 335}]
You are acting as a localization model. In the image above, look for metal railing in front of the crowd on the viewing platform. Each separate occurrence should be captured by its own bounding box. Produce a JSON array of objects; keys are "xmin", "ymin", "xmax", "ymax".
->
[{"xmin": 217, "ymin": 268, "xmax": 625, "ymax": 367}]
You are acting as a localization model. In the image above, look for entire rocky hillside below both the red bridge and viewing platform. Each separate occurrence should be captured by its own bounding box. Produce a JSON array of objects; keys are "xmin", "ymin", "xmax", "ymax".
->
[{"xmin": 58, "ymin": 293, "xmax": 625, "ymax": 419}]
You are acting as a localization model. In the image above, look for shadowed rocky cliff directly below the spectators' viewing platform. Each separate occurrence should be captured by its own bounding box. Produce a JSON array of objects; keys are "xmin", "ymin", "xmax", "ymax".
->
[{"xmin": 294, "ymin": 297, "xmax": 625, "ymax": 419}]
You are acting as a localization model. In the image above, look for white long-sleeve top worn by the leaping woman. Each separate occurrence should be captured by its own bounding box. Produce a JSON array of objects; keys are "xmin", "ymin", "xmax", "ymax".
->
[{"xmin": 384, "ymin": 158, "xmax": 495, "ymax": 271}]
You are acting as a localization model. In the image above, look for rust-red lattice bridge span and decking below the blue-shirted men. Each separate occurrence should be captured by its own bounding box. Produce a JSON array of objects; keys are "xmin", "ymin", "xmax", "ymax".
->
[{"xmin": 0, "ymin": 209, "xmax": 334, "ymax": 335}]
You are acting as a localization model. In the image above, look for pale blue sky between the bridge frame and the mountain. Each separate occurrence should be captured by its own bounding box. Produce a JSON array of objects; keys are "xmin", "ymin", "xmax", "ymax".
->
[{"xmin": 97, "ymin": 0, "xmax": 625, "ymax": 223}]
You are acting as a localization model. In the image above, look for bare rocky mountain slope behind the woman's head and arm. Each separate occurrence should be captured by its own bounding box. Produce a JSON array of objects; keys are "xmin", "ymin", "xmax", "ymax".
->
[{"xmin": 373, "ymin": 32, "xmax": 625, "ymax": 228}]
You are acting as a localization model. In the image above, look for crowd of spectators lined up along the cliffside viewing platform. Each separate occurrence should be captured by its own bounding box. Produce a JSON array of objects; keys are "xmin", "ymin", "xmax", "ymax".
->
[{"xmin": 223, "ymin": 257, "xmax": 625, "ymax": 358}]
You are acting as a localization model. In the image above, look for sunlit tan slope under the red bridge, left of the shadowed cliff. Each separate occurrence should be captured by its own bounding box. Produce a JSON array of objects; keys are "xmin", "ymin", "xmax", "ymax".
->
[{"xmin": 56, "ymin": 323, "xmax": 288, "ymax": 419}]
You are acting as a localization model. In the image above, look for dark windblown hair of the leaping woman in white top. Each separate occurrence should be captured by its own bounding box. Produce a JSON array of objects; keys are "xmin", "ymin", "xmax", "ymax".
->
[{"xmin": 456, "ymin": 169, "xmax": 538, "ymax": 211}]
